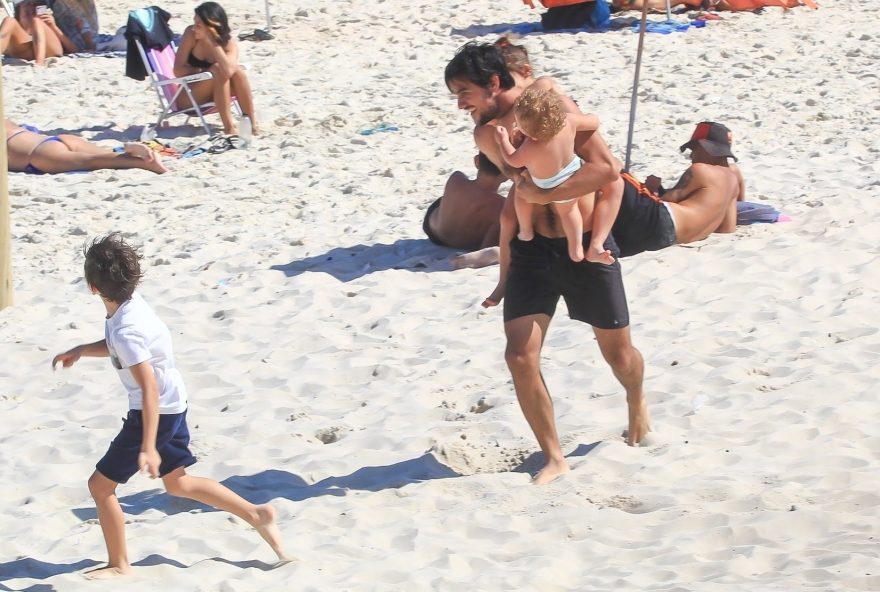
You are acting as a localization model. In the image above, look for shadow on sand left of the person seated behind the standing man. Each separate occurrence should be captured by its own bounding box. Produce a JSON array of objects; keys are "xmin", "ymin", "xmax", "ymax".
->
[{"xmin": 270, "ymin": 238, "xmax": 457, "ymax": 282}]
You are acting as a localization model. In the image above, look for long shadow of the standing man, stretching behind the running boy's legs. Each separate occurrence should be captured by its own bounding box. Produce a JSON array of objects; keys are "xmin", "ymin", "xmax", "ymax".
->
[{"xmin": 73, "ymin": 453, "xmax": 460, "ymax": 520}]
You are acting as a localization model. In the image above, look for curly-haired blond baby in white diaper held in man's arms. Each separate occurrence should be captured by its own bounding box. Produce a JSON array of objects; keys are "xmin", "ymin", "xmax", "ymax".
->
[{"xmin": 495, "ymin": 85, "xmax": 614, "ymax": 265}]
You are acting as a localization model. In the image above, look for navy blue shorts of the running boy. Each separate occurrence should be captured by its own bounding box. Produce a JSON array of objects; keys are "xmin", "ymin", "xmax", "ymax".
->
[{"xmin": 95, "ymin": 409, "xmax": 196, "ymax": 483}]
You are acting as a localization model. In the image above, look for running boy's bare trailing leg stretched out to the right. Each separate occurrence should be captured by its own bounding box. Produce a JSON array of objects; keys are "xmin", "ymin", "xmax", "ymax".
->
[{"xmin": 162, "ymin": 467, "xmax": 290, "ymax": 561}]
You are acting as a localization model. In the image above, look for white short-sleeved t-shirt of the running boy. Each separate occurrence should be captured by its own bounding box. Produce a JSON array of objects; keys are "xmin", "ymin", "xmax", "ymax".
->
[{"xmin": 104, "ymin": 292, "xmax": 187, "ymax": 414}]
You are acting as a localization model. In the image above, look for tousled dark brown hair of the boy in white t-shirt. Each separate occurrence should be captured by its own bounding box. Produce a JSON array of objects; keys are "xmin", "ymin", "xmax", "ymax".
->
[{"xmin": 83, "ymin": 232, "xmax": 143, "ymax": 304}]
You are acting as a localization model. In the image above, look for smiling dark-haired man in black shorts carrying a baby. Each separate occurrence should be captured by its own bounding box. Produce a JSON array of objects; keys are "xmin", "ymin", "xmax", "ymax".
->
[{"xmin": 445, "ymin": 43, "xmax": 650, "ymax": 484}]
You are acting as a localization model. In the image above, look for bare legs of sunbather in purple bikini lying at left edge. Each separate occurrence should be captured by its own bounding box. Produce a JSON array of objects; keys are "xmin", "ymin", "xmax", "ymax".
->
[{"xmin": 30, "ymin": 134, "xmax": 168, "ymax": 174}]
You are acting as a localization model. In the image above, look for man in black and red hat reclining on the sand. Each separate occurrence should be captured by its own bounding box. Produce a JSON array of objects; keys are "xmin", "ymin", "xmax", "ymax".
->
[{"xmin": 517, "ymin": 122, "xmax": 745, "ymax": 257}]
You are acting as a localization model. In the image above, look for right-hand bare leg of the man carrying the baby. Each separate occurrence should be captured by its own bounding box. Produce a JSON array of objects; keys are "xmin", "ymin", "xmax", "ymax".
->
[{"xmin": 593, "ymin": 327, "xmax": 651, "ymax": 446}]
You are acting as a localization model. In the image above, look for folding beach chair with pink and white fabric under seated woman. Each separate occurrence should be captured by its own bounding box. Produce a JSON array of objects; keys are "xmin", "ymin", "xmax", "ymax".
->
[{"xmin": 134, "ymin": 39, "xmax": 242, "ymax": 135}]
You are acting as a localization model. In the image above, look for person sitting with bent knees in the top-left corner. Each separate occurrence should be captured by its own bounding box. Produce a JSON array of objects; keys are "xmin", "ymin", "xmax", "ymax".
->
[{"xmin": 0, "ymin": 2, "xmax": 64, "ymax": 66}]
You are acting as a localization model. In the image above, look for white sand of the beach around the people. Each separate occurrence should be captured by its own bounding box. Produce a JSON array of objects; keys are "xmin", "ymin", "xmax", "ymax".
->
[{"xmin": 0, "ymin": 0, "xmax": 880, "ymax": 592}]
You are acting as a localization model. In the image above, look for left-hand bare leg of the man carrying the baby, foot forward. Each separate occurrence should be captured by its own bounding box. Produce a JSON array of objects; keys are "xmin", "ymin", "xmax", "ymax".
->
[{"xmin": 504, "ymin": 315, "xmax": 569, "ymax": 485}]
